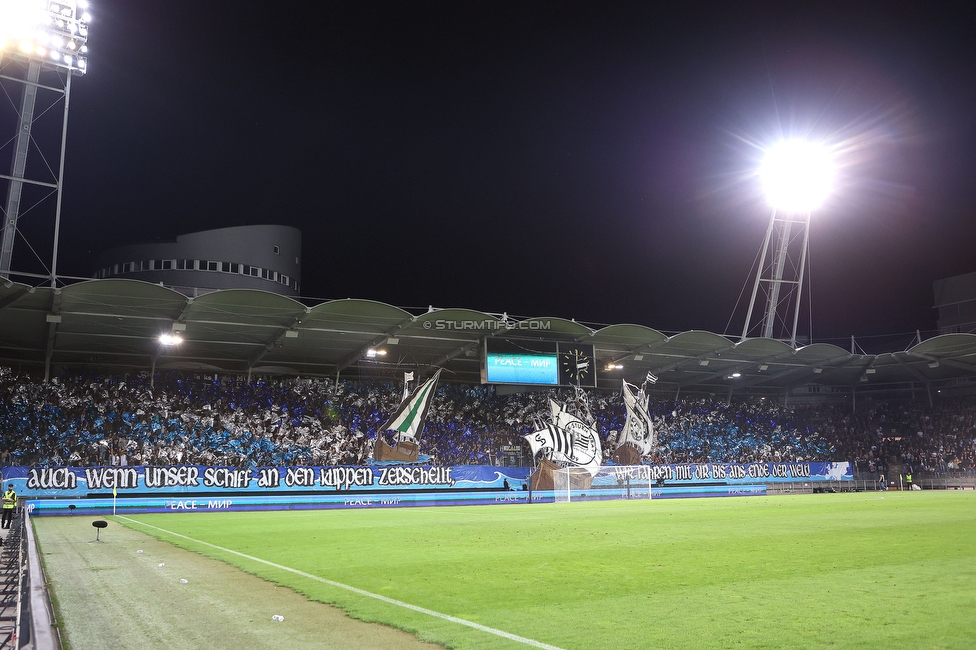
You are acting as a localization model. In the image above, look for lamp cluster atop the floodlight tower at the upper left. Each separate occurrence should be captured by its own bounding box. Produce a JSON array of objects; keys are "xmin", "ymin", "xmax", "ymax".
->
[{"xmin": 0, "ymin": 0, "xmax": 91, "ymax": 75}]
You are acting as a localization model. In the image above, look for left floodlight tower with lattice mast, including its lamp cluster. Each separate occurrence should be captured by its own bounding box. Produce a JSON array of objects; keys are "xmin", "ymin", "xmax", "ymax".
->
[{"xmin": 0, "ymin": 0, "xmax": 91, "ymax": 287}]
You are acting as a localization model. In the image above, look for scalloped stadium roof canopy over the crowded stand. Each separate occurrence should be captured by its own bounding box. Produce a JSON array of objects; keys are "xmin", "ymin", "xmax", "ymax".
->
[{"xmin": 0, "ymin": 279, "xmax": 976, "ymax": 396}]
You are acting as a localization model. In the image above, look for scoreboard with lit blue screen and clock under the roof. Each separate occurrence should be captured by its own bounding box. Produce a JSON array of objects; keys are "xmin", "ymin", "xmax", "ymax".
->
[{"xmin": 481, "ymin": 338, "xmax": 596, "ymax": 387}]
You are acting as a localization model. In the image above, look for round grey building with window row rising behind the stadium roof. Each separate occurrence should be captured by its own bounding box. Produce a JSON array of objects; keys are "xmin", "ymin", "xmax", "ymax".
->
[{"xmin": 95, "ymin": 225, "xmax": 302, "ymax": 296}]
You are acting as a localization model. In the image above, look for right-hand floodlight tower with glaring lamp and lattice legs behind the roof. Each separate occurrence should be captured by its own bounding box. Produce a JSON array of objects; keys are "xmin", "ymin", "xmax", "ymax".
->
[{"xmin": 739, "ymin": 140, "xmax": 833, "ymax": 348}]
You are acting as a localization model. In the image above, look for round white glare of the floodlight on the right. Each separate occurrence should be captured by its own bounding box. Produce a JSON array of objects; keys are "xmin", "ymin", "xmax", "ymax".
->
[{"xmin": 759, "ymin": 140, "xmax": 834, "ymax": 212}]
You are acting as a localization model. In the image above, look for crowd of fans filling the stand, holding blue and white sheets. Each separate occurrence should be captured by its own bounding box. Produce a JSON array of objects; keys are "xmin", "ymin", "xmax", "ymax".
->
[{"xmin": 0, "ymin": 369, "xmax": 976, "ymax": 471}]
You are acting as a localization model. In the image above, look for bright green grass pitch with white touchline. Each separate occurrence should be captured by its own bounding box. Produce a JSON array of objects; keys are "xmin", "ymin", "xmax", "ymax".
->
[{"xmin": 116, "ymin": 492, "xmax": 976, "ymax": 649}]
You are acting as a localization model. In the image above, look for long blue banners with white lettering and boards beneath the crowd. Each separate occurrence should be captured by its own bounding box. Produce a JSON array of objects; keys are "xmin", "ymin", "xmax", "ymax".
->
[{"xmin": 3, "ymin": 463, "xmax": 853, "ymax": 515}]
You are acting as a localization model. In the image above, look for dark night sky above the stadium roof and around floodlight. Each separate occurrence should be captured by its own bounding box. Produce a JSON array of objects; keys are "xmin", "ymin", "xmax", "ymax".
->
[{"xmin": 22, "ymin": 0, "xmax": 976, "ymax": 346}]
